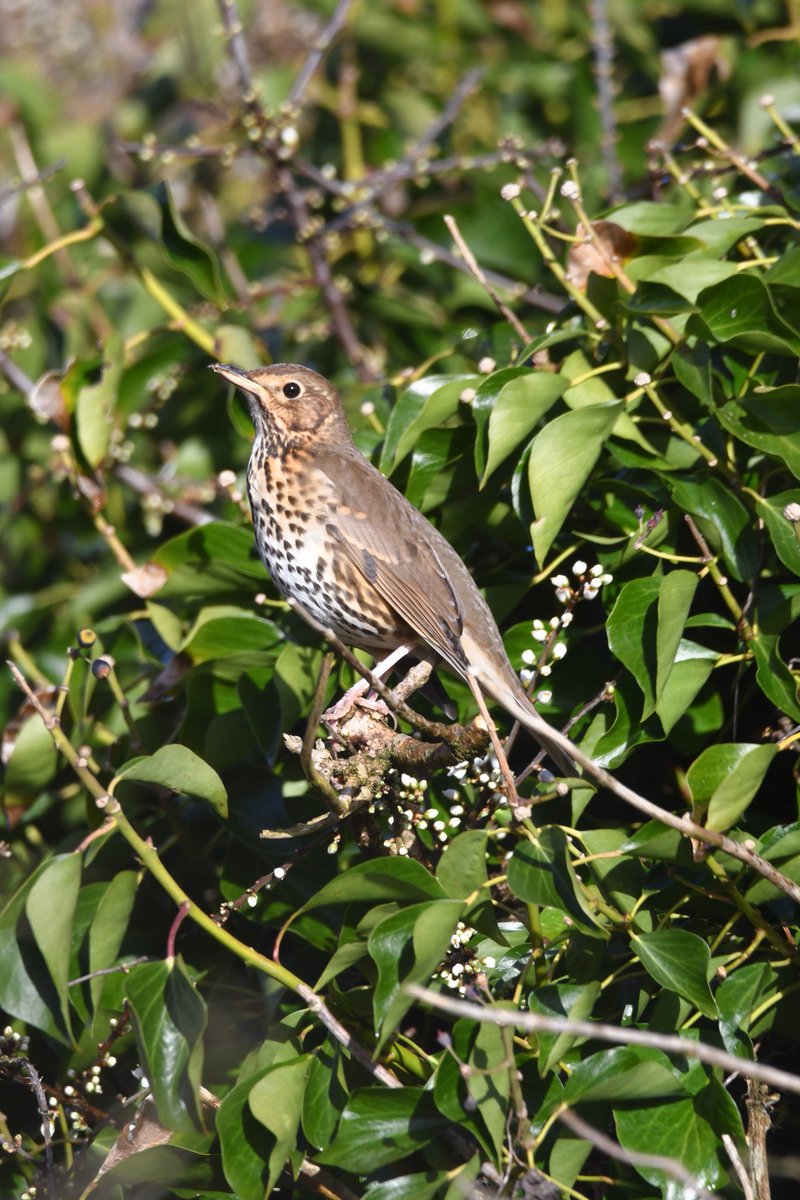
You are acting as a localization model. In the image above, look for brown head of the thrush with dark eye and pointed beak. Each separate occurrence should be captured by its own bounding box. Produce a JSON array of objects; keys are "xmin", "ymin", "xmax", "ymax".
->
[{"xmin": 211, "ymin": 362, "xmax": 350, "ymax": 452}]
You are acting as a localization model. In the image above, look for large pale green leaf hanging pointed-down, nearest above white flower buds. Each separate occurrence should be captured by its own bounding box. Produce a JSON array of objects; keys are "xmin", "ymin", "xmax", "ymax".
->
[{"xmin": 528, "ymin": 401, "xmax": 622, "ymax": 566}]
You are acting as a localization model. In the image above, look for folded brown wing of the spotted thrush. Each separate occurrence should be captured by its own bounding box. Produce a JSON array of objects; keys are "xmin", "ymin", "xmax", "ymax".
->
[{"xmin": 317, "ymin": 454, "xmax": 467, "ymax": 674}]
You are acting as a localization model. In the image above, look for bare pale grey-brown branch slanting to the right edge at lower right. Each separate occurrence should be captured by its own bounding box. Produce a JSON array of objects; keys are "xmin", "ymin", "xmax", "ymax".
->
[{"xmin": 405, "ymin": 983, "xmax": 800, "ymax": 1093}]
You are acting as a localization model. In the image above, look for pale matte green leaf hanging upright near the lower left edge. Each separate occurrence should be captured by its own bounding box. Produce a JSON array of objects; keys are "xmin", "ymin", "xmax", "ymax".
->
[{"xmin": 25, "ymin": 854, "xmax": 80, "ymax": 1032}]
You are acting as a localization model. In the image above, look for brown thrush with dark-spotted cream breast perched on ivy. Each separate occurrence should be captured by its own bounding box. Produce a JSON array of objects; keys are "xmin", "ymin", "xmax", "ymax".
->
[{"xmin": 211, "ymin": 362, "xmax": 577, "ymax": 775}]
